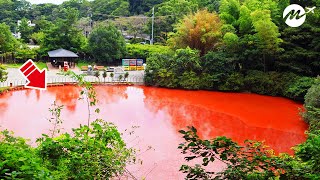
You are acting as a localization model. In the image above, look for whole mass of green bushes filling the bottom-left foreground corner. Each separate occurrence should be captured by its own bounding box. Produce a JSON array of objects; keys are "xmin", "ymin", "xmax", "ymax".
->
[{"xmin": 0, "ymin": 120, "xmax": 134, "ymax": 179}]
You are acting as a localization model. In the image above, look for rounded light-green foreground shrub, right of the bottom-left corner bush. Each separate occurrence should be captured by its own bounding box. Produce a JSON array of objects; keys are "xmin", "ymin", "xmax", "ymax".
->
[{"xmin": 37, "ymin": 120, "xmax": 133, "ymax": 179}]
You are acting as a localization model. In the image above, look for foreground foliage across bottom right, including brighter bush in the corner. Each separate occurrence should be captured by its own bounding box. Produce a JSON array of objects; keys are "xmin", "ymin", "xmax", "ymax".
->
[{"xmin": 178, "ymin": 127, "xmax": 320, "ymax": 180}]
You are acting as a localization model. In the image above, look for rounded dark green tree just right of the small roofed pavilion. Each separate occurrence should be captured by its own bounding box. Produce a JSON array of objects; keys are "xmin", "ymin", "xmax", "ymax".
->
[{"xmin": 88, "ymin": 24, "xmax": 126, "ymax": 62}]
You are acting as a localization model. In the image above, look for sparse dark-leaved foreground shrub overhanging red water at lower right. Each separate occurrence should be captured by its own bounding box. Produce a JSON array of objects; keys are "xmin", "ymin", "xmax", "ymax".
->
[{"xmin": 178, "ymin": 127, "xmax": 301, "ymax": 180}]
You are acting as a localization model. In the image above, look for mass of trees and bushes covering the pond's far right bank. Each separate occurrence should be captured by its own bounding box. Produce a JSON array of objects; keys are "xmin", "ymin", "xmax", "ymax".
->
[{"xmin": 145, "ymin": 0, "xmax": 320, "ymax": 100}]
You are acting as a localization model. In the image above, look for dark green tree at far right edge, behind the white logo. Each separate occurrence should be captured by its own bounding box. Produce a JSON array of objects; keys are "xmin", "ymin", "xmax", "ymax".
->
[{"xmin": 276, "ymin": 0, "xmax": 320, "ymax": 76}]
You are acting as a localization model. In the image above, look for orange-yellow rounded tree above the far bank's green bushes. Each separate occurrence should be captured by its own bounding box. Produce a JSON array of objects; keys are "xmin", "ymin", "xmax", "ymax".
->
[{"xmin": 168, "ymin": 10, "xmax": 222, "ymax": 56}]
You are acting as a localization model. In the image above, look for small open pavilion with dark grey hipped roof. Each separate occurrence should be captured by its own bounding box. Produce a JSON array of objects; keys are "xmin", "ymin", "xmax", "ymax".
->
[{"xmin": 48, "ymin": 49, "xmax": 79, "ymax": 68}]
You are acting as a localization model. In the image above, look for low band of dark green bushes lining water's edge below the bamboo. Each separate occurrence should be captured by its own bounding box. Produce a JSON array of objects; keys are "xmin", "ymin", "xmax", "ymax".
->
[{"xmin": 145, "ymin": 48, "xmax": 314, "ymax": 101}]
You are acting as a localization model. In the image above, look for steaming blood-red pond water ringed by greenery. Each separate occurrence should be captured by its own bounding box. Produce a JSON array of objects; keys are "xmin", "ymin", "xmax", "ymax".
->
[{"xmin": 0, "ymin": 86, "xmax": 307, "ymax": 179}]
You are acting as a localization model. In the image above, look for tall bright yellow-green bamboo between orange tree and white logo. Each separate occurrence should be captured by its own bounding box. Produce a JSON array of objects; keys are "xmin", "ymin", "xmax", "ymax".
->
[{"xmin": 220, "ymin": 0, "xmax": 285, "ymax": 70}]
